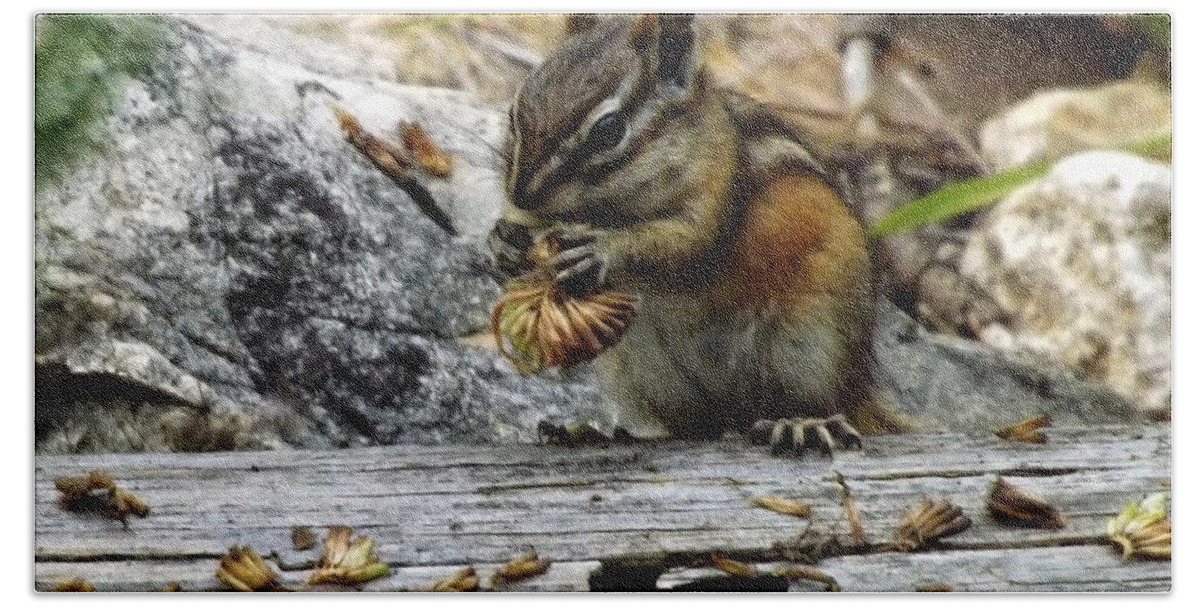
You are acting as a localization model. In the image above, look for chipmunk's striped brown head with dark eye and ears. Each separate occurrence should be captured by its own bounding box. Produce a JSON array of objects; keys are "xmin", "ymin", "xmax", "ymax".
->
[{"xmin": 505, "ymin": 14, "xmax": 703, "ymax": 223}]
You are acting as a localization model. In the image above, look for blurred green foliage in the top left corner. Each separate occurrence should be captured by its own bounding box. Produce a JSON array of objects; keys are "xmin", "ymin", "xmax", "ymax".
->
[{"xmin": 34, "ymin": 14, "xmax": 164, "ymax": 188}]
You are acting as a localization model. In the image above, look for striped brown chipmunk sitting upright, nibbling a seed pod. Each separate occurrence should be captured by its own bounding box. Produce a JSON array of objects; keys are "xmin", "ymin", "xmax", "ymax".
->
[{"xmin": 488, "ymin": 14, "xmax": 910, "ymax": 453}]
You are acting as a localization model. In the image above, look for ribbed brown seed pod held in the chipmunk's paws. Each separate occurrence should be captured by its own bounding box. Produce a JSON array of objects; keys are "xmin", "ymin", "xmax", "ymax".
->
[{"xmin": 492, "ymin": 235, "xmax": 637, "ymax": 373}]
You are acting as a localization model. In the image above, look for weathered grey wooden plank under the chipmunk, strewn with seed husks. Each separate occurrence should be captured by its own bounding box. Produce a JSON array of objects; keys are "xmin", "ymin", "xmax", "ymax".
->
[{"xmin": 35, "ymin": 425, "xmax": 1171, "ymax": 591}]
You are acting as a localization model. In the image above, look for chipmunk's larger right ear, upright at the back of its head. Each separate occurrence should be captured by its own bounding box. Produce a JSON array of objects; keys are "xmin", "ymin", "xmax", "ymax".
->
[{"xmin": 629, "ymin": 14, "xmax": 696, "ymax": 95}]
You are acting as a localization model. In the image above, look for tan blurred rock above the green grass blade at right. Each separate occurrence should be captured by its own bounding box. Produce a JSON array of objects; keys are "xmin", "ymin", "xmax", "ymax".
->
[{"xmin": 979, "ymin": 80, "xmax": 1171, "ymax": 170}]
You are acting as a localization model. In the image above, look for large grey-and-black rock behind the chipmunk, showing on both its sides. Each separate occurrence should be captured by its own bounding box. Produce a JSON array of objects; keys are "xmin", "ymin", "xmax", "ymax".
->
[{"xmin": 35, "ymin": 19, "xmax": 1147, "ymax": 452}]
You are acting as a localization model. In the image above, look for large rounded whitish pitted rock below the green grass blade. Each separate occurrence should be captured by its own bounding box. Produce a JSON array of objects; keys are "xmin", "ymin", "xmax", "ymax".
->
[{"xmin": 962, "ymin": 152, "xmax": 1171, "ymax": 414}]
